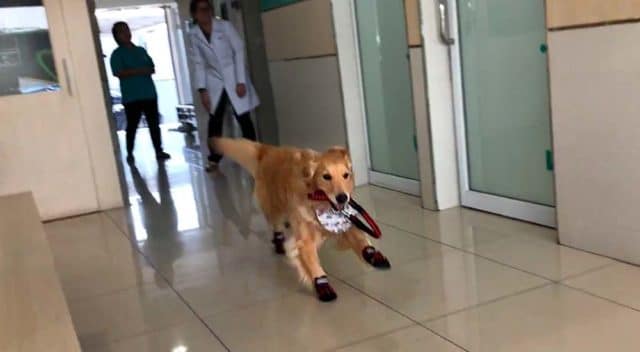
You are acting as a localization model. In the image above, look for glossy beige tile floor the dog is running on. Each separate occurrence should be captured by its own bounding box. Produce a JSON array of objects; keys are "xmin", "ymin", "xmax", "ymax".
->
[{"xmin": 46, "ymin": 131, "xmax": 640, "ymax": 352}]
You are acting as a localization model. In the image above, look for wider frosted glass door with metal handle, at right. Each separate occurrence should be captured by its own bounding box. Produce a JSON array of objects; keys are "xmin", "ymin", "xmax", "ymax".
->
[{"xmin": 448, "ymin": 0, "xmax": 555, "ymax": 226}]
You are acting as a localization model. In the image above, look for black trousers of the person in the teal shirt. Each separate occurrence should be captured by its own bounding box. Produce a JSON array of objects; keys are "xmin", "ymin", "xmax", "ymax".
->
[{"xmin": 124, "ymin": 99, "xmax": 162, "ymax": 155}]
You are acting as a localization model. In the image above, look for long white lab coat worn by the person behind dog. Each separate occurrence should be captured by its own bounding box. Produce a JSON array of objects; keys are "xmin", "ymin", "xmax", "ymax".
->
[{"xmin": 189, "ymin": 19, "xmax": 260, "ymax": 115}]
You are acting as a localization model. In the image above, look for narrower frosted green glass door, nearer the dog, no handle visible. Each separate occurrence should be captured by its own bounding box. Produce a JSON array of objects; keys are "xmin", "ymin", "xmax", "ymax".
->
[{"xmin": 355, "ymin": 0, "xmax": 420, "ymax": 195}]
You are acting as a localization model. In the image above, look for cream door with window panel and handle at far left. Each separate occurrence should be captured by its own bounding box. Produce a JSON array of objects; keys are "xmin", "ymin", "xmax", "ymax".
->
[{"xmin": 0, "ymin": 0, "xmax": 98, "ymax": 219}]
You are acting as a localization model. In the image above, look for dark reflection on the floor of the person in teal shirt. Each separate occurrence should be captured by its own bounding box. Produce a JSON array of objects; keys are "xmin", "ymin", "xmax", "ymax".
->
[{"xmin": 131, "ymin": 164, "xmax": 183, "ymax": 286}]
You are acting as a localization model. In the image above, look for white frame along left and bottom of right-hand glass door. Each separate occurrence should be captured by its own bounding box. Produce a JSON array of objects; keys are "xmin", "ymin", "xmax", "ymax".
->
[{"xmin": 447, "ymin": 0, "xmax": 556, "ymax": 227}]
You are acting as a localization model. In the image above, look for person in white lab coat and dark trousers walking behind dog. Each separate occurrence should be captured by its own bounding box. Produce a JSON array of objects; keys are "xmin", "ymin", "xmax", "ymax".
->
[{"xmin": 189, "ymin": 0, "xmax": 260, "ymax": 171}]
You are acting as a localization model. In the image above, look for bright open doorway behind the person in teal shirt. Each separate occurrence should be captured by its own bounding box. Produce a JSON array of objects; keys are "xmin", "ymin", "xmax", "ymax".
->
[{"xmin": 95, "ymin": 3, "xmax": 204, "ymax": 158}]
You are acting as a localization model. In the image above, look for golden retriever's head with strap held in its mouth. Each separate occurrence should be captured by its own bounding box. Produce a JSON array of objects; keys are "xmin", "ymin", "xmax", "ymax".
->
[{"xmin": 306, "ymin": 147, "xmax": 355, "ymax": 208}]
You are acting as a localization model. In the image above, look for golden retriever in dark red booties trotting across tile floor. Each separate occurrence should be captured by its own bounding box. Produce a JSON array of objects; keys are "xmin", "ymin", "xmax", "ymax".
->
[{"xmin": 210, "ymin": 138, "xmax": 390, "ymax": 302}]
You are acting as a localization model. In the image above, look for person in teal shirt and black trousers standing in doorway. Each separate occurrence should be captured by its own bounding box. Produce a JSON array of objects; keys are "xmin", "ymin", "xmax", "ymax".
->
[{"xmin": 111, "ymin": 22, "xmax": 170, "ymax": 163}]
